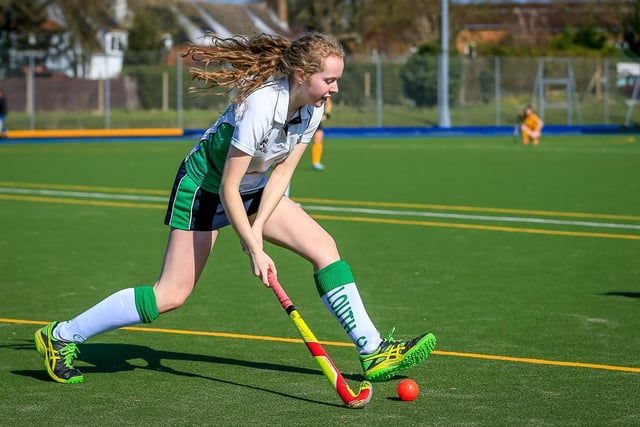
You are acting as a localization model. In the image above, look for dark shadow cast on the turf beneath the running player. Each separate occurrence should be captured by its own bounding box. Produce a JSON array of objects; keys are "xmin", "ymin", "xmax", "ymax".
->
[{"xmin": 8, "ymin": 341, "xmax": 370, "ymax": 408}]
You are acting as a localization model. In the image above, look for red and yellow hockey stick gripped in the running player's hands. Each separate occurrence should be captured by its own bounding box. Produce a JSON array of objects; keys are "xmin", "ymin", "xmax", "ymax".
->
[{"xmin": 269, "ymin": 272, "xmax": 373, "ymax": 409}]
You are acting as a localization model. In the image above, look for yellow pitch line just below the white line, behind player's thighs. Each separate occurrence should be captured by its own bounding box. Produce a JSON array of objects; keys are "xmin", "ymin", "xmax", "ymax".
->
[{"xmin": 0, "ymin": 194, "xmax": 640, "ymax": 240}]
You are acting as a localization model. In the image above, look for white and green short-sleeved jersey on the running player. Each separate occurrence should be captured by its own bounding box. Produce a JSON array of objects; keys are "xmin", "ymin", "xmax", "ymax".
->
[{"xmin": 185, "ymin": 77, "xmax": 324, "ymax": 193}]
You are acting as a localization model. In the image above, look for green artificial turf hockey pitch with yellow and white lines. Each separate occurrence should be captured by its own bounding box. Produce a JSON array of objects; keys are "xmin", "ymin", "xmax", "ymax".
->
[{"xmin": 0, "ymin": 135, "xmax": 640, "ymax": 426}]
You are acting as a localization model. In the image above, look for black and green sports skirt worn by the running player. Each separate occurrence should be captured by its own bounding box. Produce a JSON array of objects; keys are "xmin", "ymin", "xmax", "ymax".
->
[{"xmin": 164, "ymin": 163, "xmax": 263, "ymax": 231}]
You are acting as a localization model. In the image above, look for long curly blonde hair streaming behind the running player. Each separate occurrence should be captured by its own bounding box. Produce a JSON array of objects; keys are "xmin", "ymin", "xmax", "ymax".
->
[{"xmin": 184, "ymin": 33, "xmax": 344, "ymax": 103}]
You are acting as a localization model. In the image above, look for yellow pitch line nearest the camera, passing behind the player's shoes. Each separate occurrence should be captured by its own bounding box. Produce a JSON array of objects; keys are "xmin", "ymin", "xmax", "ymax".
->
[{"xmin": 0, "ymin": 317, "xmax": 640, "ymax": 373}]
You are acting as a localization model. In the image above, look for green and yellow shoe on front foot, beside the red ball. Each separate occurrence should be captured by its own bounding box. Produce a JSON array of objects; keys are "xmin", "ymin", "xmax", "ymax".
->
[{"xmin": 360, "ymin": 328, "xmax": 436, "ymax": 382}]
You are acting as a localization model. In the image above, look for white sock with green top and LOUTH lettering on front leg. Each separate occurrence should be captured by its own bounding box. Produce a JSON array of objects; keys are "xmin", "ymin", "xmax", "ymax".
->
[{"xmin": 313, "ymin": 260, "xmax": 382, "ymax": 354}]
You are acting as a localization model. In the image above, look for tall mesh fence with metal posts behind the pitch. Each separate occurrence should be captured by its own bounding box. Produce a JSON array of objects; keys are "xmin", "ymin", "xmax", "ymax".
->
[{"xmin": 0, "ymin": 52, "xmax": 640, "ymax": 130}]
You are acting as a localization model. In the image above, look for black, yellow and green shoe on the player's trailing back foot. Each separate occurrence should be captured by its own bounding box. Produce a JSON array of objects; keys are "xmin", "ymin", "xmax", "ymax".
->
[{"xmin": 34, "ymin": 322, "xmax": 84, "ymax": 384}]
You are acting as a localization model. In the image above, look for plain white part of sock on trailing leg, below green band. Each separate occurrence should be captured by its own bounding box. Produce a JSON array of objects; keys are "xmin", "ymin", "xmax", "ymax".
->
[{"xmin": 53, "ymin": 288, "xmax": 142, "ymax": 343}]
